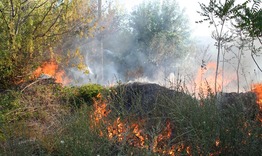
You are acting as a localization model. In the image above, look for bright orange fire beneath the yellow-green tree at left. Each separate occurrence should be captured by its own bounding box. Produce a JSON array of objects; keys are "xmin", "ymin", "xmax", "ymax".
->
[{"xmin": 32, "ymin": 60, "xmax": 70, "ymax": 84}]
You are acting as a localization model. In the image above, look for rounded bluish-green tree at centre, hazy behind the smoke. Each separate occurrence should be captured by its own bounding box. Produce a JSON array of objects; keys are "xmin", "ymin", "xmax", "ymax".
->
[{"xmin": 129, "ymin": 0, "xmax": 190, "ymax": 76}]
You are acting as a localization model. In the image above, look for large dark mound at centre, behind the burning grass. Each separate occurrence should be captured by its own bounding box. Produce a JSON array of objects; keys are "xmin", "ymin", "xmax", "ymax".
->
[{"xmin": 109, "ymin": 82, "xmax": 195, "ymax": 116}]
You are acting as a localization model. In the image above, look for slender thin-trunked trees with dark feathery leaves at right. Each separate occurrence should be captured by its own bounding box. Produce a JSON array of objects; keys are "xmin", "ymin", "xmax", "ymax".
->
[{"xmin": 197, "ymin": 0, "xmax": 262, "ymax": 93}]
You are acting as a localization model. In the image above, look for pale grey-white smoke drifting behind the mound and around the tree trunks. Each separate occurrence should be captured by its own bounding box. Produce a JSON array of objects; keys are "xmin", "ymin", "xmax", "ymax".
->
[{"xmin": 64, "ymin": 1, "xmax": 262, "ymax": 92}]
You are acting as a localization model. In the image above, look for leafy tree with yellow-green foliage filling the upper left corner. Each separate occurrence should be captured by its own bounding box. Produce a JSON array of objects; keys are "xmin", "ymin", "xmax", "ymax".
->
[{"xmin": 0, "ymin": 0, "xmax": 96, "ymax": 88}]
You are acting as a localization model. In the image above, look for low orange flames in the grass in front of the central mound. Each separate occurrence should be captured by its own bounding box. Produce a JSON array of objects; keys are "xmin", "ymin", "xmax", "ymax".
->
[{"xmin": 91, "ymin": 94, "xmax": 190, "ymax": 156}]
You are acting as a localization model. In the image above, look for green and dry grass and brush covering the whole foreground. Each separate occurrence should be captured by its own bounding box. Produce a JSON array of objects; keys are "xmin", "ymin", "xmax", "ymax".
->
[{"xmin": 0, "ymin": 81, "xmax": 262, "ymax": 156}]
